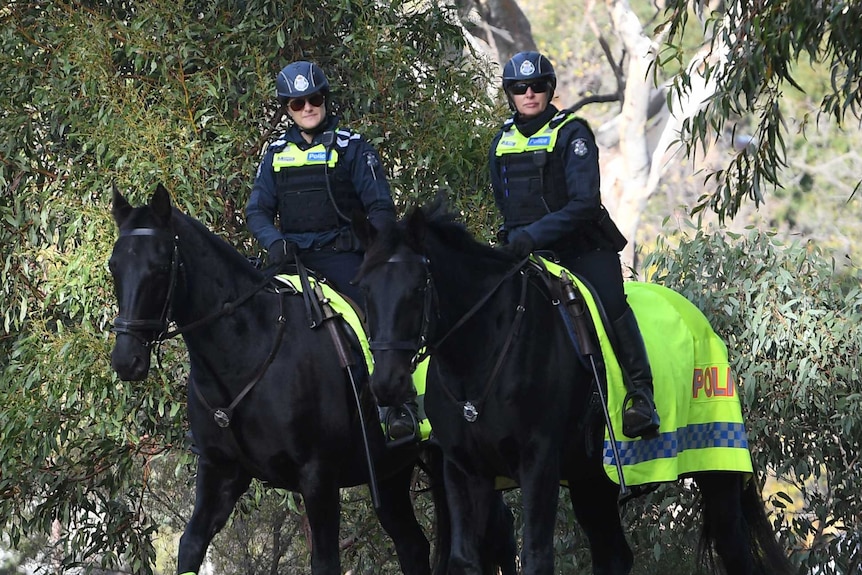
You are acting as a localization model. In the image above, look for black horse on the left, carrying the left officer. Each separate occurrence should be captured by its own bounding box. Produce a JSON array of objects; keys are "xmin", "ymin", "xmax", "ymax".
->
[{"xmin": 109, "ymin": 184, "xmax": 515, "ymax": 575}]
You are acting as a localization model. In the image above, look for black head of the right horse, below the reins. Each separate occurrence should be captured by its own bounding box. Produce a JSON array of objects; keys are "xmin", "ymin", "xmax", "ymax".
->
[{"xmin": 354, "ymin": 209, "xmax": 433, "ymax": 406}]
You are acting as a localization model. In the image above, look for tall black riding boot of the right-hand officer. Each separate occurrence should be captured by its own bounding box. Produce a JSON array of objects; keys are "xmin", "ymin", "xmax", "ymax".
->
[{"xmin": 613, "ymin": 308, "xmax": 659, "ymax": 439}]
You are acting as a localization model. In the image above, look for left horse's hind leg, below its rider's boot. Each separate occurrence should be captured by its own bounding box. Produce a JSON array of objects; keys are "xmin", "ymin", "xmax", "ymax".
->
[{"xmin": 376, "ymin": 466, "xmax": 431, "ymax": 575}]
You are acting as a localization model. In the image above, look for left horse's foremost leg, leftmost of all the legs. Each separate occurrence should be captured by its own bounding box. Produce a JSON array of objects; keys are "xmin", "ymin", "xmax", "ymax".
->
[{"xmin": 177, "ymin": 457, "xmax": 251, "ymax": 574}]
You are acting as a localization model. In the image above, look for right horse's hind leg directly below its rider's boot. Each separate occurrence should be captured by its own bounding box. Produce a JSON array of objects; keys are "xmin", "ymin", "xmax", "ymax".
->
[{"xmin": 569, "ymin": 469, "xmax": 634, "ymax": 575}]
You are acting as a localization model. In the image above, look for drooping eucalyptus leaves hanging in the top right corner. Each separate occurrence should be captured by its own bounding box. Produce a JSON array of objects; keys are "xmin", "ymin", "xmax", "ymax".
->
[{"xmin": 663, "ymin": 0, "xmax": 862, "ymax": 217}]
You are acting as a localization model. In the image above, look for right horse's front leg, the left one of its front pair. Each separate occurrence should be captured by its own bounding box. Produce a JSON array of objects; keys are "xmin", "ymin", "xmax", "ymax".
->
[{"xmin": 444, "ymin": 459, "xmax": 498, "ymax": 575}]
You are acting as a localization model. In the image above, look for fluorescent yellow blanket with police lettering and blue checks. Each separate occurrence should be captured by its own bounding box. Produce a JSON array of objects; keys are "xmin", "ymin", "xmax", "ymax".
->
[{"xmin": 544, "ymin": 261, "xmax": 752, "ymax": 485}]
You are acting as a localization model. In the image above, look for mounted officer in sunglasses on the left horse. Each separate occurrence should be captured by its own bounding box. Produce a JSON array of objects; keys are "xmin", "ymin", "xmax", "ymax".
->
[{"xmin": 245, "ymin": 61, "xmax": 416, "ymax": 439}]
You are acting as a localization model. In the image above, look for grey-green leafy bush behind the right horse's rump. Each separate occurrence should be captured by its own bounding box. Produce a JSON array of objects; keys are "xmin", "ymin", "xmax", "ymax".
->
[{"xmin": 644, "ymin": 218, "xmax": 862, "ymax": 574}]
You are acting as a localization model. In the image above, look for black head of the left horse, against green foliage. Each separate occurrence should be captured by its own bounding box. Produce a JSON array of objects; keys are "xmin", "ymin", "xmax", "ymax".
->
[{"xmin": 108, "ymin": 184, "xmax": 178, "ymax": 381}]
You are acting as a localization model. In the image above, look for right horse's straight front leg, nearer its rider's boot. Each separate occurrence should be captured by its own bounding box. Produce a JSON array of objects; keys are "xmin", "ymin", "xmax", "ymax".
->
[{"xmin": 520, "ymin": 445, "xmax": 560, "ymax": 575}]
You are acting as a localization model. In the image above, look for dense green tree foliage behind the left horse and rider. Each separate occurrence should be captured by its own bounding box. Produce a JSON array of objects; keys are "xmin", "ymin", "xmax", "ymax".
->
[{"xmin": 0, "ymin": 0, "xmax": 498, "ymax": 573}]
